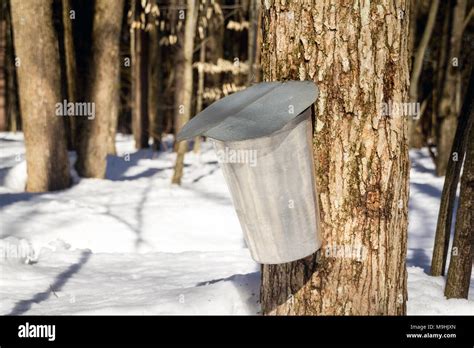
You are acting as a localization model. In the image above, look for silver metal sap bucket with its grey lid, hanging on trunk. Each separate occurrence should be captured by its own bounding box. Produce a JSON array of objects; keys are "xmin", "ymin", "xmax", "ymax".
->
[{"xmin": 178, "ymin": 81, "xmax": 321, "ymax": 264}]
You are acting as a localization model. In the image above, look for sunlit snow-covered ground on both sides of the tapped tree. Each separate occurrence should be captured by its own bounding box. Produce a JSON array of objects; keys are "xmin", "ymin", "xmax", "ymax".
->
[{"xmin": 0, "ymin": 133, "xmax": 474, "ymax": 315}]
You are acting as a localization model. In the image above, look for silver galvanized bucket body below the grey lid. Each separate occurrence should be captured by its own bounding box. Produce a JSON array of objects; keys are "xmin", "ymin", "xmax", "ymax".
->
[{"xmin": 214, "ymin": 109, "xmax": 321, "ymax": 264}]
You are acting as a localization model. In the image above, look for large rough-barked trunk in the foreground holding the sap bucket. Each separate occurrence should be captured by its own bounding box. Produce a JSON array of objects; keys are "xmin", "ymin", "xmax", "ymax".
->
[{"xmin": 261, "ymin": 0, "xmax": 410, "ymax": 315}]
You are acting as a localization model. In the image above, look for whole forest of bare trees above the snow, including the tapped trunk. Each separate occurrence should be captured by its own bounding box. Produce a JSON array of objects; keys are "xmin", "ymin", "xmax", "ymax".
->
[{"xmin": 0, "ymin": 0, "xmax": 474, "ymax": 315}]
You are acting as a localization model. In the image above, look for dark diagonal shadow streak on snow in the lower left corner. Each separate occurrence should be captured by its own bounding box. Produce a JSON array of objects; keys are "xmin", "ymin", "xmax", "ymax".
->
[{"xmin": 7, "ymin": 250, "xmax": 92, "ymax": 315}]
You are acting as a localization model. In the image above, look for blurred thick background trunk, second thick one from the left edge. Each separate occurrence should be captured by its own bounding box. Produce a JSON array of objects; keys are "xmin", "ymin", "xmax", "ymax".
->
[{"xmin": 76, "ymin": 0, "xmax": 124, "ymax": 179}]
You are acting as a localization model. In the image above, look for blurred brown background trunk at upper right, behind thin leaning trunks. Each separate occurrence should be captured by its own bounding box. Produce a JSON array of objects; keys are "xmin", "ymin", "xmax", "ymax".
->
[{"xmin": 436, "ymin": 0, "xmax": 466, "ymax": 176}]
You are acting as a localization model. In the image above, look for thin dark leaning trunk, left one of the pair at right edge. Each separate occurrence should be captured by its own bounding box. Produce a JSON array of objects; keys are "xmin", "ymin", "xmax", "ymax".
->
[{"xmin": 431, "ymin": 72, "xmax": 474, "ymax": 276}]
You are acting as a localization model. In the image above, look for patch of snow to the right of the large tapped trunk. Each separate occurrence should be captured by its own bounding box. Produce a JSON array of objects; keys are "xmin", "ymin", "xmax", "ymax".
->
[{"xmin": 407, "ymin": 149, "xmax": 474, "ymax": 315}]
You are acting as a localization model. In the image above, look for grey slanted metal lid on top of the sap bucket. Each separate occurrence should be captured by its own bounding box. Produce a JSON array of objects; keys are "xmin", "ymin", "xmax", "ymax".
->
[{"xmin": 177, "ymin": 81, "xmax": 318, "ymax": 141}]
